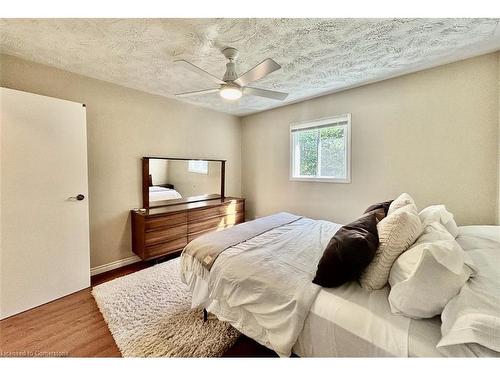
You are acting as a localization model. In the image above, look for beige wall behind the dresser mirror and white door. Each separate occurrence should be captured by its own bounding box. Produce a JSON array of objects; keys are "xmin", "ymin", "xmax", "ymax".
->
[{"xmin": 0, "ymin": 55, "xmax": 241, "ymax": 266}]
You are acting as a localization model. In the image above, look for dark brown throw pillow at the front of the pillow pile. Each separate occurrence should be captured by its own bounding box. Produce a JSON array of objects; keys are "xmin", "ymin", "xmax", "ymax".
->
[{"xmin": 313, "ymin": 212, "xmax": 384, "ymax": 288}]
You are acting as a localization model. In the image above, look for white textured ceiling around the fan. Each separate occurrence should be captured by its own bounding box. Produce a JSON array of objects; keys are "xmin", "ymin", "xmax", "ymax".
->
[{"xmin": 0, "ymin": 19, "xmax": 500, "ymax": 115}]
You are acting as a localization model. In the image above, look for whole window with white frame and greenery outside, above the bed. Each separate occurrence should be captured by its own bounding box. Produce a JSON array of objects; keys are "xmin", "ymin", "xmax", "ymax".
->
[{"xmin": 290, "ymin": 114, "xmax": 351, "ymax": 183}]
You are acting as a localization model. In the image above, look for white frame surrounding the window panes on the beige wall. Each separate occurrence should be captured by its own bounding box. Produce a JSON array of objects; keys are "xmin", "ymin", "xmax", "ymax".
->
[{"xmin": 289, "ymin": 113, "xmax": 351, "ymax": 184}]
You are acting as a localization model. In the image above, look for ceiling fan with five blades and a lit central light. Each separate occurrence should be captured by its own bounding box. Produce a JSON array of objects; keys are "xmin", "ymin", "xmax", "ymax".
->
[{"xmin": 174, "ymin": 47, "xmax": 288, "ymax": 100}]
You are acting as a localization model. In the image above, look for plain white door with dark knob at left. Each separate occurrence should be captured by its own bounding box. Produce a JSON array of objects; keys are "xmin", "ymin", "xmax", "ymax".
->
[{"xmin": 0, "ymin": 88, "xmax": 90, "ymax": 319}]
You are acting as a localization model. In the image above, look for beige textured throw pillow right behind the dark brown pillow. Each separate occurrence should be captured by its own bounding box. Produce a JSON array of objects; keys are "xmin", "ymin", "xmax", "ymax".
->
[{"xmin": 359, "ymin": 204, "xmax": 422, "ymax": 290}]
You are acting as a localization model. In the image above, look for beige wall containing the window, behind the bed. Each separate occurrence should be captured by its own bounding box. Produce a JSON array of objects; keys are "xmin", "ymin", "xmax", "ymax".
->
[{"xmin": 242, "ymin": 54, "xmax": 499, "ymax": 224}]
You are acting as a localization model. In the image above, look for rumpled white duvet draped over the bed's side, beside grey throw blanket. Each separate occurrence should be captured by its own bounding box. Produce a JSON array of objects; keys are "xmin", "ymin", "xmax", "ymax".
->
[{"xmin": 181, "ymin": 218, "xmax": 340, "ymax": 356}]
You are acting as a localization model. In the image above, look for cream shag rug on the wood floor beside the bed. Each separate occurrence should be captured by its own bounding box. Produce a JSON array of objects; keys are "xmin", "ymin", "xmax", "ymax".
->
[{"xmin": 92, "ymin": 258, "xmax": 240, "ymax": 357}]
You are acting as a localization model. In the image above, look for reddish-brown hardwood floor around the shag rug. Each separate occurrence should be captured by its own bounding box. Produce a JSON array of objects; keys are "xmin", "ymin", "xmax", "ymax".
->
[{"xmin": 0, "ymin": 262, "xmax": 276, "ymax": 357}]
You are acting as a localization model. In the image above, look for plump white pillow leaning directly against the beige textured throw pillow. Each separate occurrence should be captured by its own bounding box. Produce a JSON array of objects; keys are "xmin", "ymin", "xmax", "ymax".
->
[{"xmin": 389, "ymin": 236, "xmax": 473, "ymax": 319}]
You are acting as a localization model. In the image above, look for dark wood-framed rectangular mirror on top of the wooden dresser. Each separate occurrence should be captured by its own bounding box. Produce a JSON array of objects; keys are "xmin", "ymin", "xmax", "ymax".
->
[{"xmin": 142, "ymin": 157, "xmax": 225, "ymax": 208}]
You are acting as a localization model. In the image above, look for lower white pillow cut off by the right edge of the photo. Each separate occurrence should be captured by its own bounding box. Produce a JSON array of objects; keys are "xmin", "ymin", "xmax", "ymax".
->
[{"xmin": 437, "ymin": 248, "xmax": 500, "ymax": 353}]
